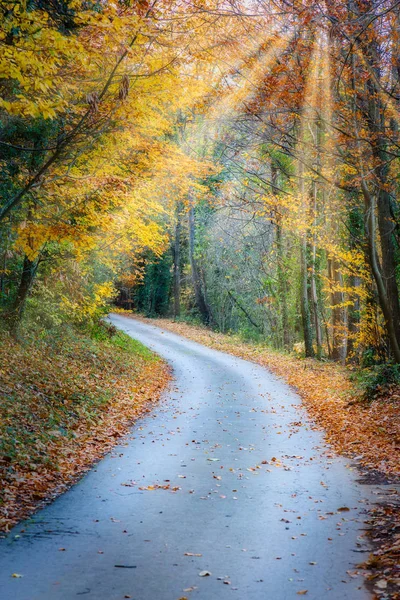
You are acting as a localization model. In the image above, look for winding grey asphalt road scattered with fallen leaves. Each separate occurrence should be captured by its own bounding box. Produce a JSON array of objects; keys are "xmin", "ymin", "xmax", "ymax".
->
[{"xmin": 0, "ymin": 315, "xmax": 370, "ymax": 600}]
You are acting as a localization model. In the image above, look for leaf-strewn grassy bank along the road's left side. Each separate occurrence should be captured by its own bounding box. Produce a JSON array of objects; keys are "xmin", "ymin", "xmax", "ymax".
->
[{"xmin": 0, "ymin": 326, "xmax": 170, "ymax": 531}]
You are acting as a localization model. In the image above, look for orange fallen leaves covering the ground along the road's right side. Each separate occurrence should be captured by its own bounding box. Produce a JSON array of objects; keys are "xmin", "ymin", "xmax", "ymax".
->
[{"xmin": 129, "ymin": 313, "xmax": 400, "ymax": 599}]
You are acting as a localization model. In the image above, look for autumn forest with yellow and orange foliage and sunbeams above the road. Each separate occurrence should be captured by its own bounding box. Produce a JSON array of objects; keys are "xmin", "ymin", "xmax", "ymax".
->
[{"xmin": 0, "ymin": 0, "xmax": 400, "ymax": 364}]
